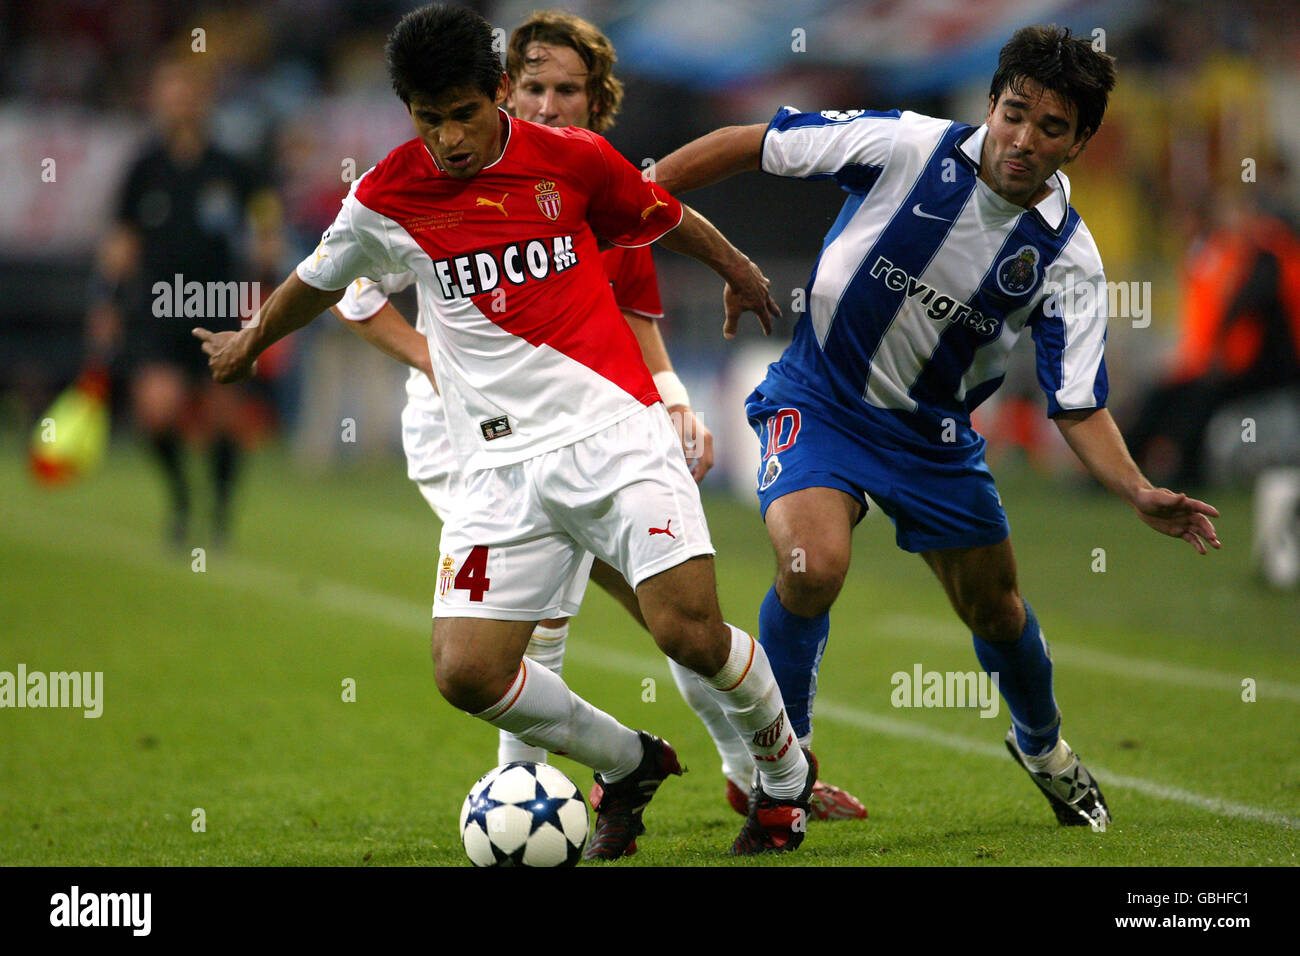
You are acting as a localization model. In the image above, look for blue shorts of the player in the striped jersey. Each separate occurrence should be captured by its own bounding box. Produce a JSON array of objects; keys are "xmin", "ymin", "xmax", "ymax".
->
[{"xmin": 745, "ymin": 390, "xmax": 1011, "ymax": 553}]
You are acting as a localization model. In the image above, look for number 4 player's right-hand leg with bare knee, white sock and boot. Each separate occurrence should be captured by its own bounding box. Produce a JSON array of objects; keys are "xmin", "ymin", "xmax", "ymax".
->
[{"xmin": 637, "ymin": 555, "xmax": 813, "ymax": 853}]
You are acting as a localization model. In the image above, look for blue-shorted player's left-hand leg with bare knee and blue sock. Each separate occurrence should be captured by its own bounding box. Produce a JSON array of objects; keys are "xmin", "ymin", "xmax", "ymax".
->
[{"xmin": 759, "ymin": 488, "xmax": 867, "ymax": 819}]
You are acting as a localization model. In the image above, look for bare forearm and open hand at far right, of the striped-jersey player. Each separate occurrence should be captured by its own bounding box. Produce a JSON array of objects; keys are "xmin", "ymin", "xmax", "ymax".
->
[{"xmin": 1054, "ymin": 408, "xmax": 1222, "ymax": 554}]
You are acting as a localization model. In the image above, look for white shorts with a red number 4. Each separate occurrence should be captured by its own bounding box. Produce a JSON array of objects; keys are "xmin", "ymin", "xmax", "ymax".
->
[{"xmin": 433, "ymin": 403, "xmax": 714, "ymax": 620}]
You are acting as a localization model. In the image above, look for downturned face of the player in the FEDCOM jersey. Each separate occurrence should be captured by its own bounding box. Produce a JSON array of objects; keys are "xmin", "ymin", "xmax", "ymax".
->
[{"xmin": 410, "ymin": 74, "xmax": 507, "ymax": 179}]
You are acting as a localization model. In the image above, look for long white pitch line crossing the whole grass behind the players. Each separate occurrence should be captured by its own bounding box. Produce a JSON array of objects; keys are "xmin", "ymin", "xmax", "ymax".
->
[{"xmin": 4, "ymin": 509, "xmax": 1300, "ymax": 830}]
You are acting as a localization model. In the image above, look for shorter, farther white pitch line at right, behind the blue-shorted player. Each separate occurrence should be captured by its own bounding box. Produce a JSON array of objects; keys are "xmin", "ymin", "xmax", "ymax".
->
[{"xmin": 872, "ymin": 614, "xmax": 1300, "ymax": 702}]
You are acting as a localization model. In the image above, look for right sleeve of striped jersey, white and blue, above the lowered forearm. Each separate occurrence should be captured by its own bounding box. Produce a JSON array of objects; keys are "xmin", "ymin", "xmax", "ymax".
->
[{"xmin": 1030, "ymin": 272, "xmax": 1110, "ymax": 416}]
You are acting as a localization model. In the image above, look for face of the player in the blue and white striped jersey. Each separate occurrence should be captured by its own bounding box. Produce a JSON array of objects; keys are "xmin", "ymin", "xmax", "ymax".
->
[{"xmin": 979, "ymin": 81, "xmax": 1087, "ymax": 208}]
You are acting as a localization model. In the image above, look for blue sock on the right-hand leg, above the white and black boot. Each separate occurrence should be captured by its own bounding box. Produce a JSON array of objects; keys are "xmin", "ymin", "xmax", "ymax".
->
[{"xmin": 977, "ymin": 601, "xmax": 1061, "ymax": 757}]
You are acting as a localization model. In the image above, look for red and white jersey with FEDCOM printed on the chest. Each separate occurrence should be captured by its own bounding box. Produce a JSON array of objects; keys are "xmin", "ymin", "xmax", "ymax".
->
[{"xmin": 298, "ymin": 112, "xmax": 681, "ymax": 471}]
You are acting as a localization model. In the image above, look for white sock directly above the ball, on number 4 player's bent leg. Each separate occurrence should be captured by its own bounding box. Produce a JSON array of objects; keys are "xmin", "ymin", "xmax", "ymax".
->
[{"xmin": 475, "ymin": 657, "xmax": 642, "ymax": 783}]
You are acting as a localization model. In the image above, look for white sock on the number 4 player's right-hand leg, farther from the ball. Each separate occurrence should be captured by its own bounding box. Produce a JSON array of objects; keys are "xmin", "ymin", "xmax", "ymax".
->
[{"xmin": 703, "ymin": 624, "xmax": 807, "ymax": 800}]
